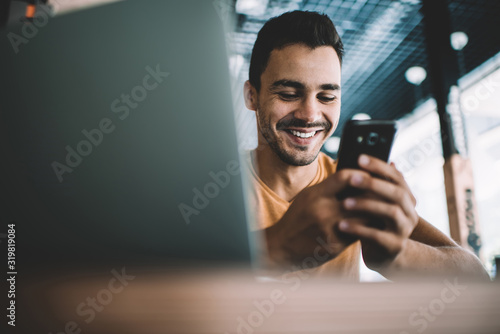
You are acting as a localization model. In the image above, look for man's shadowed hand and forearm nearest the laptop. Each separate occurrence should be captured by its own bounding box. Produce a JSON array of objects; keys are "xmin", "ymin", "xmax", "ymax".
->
[{"xmin": 264, "ymin": 170, "xmax": 361, "ymax": 268}]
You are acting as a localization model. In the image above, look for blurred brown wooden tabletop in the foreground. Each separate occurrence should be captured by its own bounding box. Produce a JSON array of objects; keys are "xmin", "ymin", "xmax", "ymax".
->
[{"xmin": 13, "ymin": 268, "xmax": 500, "ymax": 334}]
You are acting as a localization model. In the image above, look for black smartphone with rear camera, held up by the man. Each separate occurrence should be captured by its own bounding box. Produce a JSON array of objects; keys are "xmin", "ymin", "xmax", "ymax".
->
[{"xmin": 337, "ymin": 120, "xmax": 396, "ymax": 170}]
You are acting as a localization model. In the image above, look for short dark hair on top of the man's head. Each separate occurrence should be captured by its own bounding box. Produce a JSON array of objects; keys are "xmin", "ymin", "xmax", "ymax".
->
[{"xmin": 249, "ymin": 10, "xmax": 344, "ymax": 91}]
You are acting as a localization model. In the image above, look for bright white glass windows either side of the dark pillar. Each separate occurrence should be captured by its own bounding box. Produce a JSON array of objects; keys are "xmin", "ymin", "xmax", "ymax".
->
[{"xmin": 362, "ymin": 55, "xmax": 500, "ymax": 280}]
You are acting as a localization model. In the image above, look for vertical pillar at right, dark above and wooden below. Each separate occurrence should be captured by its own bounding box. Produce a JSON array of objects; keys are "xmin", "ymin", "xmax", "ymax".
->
[{"xmin": 422, "ymin": 0, "xmax": 481, "ymax": 256}]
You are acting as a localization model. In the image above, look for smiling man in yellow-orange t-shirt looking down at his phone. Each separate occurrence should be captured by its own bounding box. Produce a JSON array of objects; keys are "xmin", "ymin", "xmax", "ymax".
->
[{"xmin": 244, "ymin": 11, "xmax": 488, "ymax": 280}]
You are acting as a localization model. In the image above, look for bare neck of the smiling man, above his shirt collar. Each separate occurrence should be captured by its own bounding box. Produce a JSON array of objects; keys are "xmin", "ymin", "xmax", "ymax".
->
[{"xmin": 251, "ymin": 146, "xmax": 318, "ymax": 202}]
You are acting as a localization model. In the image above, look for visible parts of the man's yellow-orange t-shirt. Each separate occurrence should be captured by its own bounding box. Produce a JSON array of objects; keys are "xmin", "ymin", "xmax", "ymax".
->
[{"xmin": 247, "ymin": 152, "xmax": 360, "ymax": 281}]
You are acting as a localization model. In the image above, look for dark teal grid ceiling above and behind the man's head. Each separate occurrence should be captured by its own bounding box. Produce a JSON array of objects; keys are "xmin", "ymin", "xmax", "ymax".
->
[{"xmin": 230, "ymin": 0, "xmax": 500, "ymax": 135}]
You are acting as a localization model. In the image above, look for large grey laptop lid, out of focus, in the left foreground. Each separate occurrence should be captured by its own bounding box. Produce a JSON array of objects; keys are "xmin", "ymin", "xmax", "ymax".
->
[{"xmin": 0, "ymin": 1, "xmax": 251, "ymax": 270}]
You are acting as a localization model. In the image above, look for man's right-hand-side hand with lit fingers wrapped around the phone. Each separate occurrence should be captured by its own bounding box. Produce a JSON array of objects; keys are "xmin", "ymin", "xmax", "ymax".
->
[{"xmin": 339, "ymin": 155, "xmax": 419, "ymax": 270}]
